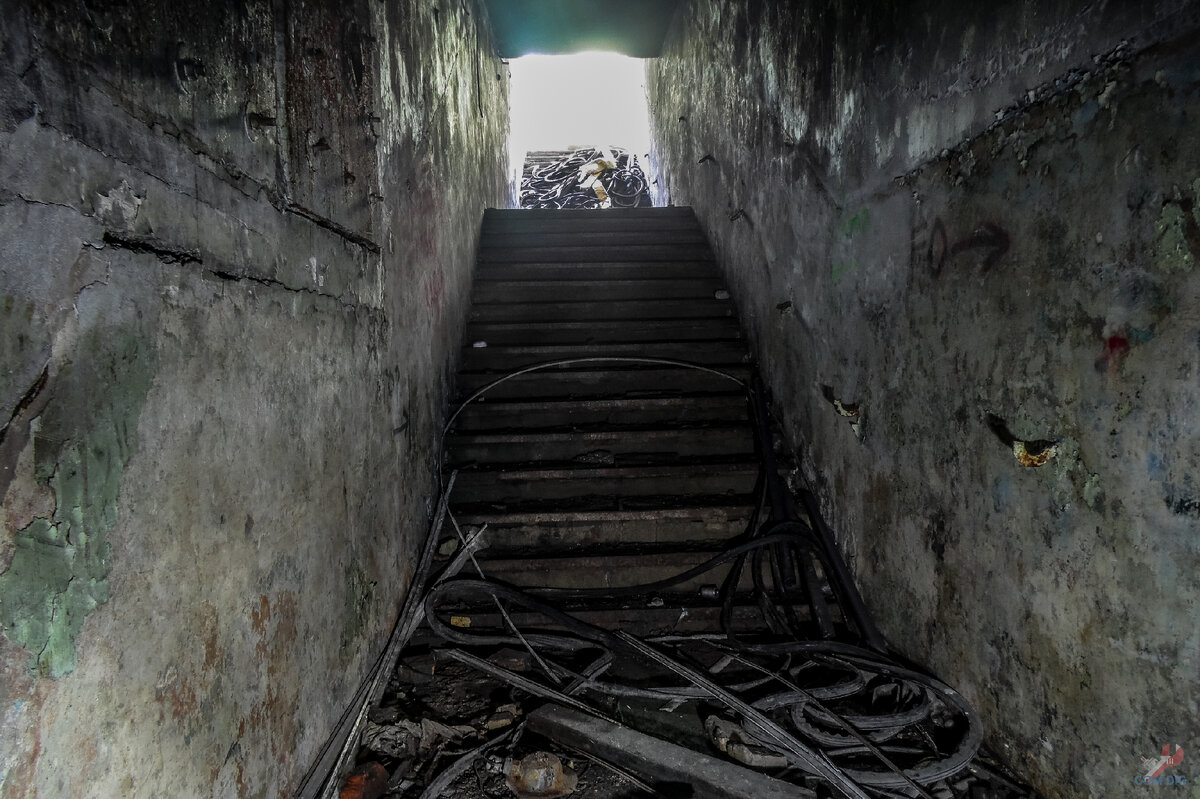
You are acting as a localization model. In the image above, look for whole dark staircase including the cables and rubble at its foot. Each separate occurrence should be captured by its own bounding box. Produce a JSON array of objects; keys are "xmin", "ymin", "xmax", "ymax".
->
[{"xmin": 326, "ymin": 209, "xmax": 1034, "ymax": 799}]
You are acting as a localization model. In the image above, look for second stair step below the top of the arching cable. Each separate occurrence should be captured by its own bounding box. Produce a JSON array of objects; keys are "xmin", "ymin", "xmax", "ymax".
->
[{"xmin": 455, "ymin": 394, "xmax": 749, "ymax": 432}]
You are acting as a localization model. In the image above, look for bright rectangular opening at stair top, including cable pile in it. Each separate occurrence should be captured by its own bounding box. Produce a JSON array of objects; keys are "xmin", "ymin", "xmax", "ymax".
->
[{"xmin": 509, "ymin": 53, "xmax": 654, "ymax": 208}]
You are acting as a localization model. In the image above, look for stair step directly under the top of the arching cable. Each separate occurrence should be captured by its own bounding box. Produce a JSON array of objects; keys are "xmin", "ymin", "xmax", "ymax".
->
[{"xmin": 458, "ymin": 364, "xmax": 750, "ymax": 401}]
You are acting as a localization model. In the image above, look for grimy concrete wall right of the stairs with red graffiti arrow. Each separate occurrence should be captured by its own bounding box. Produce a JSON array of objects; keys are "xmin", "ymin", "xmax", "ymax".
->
[{"xmin": 648, "ymin": 0, "xmax": 1200, "ymax": 797}]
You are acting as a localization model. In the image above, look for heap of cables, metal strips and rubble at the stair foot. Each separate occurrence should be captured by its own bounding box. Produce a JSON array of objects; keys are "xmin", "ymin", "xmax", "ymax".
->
[{"xmin": 331, "ymin": 384, "xmax": 1033, "ymax": 799}]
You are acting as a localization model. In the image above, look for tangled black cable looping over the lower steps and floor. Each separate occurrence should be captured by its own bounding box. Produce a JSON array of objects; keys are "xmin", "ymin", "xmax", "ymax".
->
[{"xmin": 424, "ymin": 358, "xmax": 983, "ymax": 799}]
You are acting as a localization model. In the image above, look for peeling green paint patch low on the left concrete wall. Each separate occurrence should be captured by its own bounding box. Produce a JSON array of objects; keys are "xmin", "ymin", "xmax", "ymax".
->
[{"xmin": 0, "ymin": 316, "xmax": 155, "ymax": 678}]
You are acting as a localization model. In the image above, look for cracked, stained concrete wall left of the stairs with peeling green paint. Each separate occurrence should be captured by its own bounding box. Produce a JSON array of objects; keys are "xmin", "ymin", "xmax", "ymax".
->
[{"xmin": 0, "ymin": 0, "xmax": 509, "ymax": 797}]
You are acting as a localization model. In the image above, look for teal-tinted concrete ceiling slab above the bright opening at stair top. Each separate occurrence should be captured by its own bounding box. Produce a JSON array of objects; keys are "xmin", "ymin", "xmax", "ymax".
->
[{"xmin": 485, "ymin": 0, "xmax": 678, "ymax": 58}]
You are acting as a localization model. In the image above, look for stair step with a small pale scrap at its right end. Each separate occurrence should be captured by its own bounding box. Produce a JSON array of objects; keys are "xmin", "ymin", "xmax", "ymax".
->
[{"xmin": 472, "ymin": 277, "xmax": 727, "ymax": 304}]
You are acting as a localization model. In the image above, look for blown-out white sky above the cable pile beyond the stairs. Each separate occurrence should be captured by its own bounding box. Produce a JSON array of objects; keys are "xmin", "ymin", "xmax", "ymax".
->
[{"xmin": 509, "ymin": 53, "xmax": 650, "ymax": 157}]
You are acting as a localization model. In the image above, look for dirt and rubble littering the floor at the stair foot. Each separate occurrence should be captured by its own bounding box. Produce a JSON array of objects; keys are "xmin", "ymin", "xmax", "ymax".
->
[{"xmin": 342, "ymin": 643, "xmax": 1034, "ymax": 799}]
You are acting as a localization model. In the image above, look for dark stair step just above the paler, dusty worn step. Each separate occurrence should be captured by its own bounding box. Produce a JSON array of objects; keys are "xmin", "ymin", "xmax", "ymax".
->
[{"xmin": 452, "ymin": 461, "xmax": 758, "ymax": 503}]
